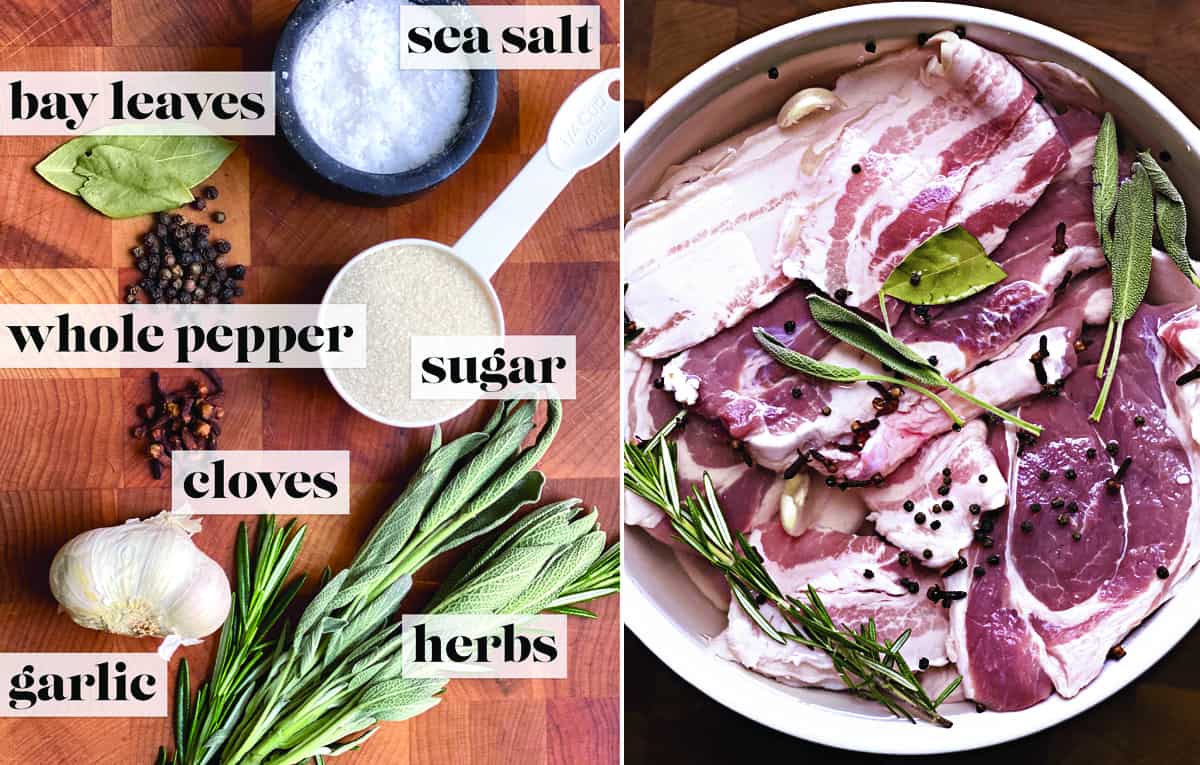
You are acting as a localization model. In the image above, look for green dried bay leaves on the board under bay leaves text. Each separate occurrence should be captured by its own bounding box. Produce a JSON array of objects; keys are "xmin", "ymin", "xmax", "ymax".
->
[{"xmin": 34, "ymin": 135, "xmax": 238, "ymax": 218}]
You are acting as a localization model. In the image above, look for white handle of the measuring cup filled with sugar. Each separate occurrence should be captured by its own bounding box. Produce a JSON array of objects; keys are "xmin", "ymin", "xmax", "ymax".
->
[{"xmin": 454, "ymin": 68, "xmax": 620, "ymax": 278}]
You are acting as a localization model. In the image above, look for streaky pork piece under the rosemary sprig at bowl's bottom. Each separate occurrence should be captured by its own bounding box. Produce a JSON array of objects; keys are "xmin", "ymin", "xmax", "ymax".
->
[{"xmin": 713, "ymin": 524, "xmax": 949, "ymax": 691}]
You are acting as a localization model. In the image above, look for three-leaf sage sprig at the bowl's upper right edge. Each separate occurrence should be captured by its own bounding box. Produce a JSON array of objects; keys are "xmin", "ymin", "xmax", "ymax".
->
[{"xmin": 1091, "ymin": 114, "xmax": 1200, "ymax": 422}]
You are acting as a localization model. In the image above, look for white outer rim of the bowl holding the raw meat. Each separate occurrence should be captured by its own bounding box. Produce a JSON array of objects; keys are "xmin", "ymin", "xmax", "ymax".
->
[{"xmin": 622, "ymin": 2, "xmax": 1200, "ymax": 754}]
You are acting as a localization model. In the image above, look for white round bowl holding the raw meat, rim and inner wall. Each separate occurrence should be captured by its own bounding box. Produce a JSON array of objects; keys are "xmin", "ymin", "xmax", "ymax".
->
[{"xmin": 622, "ymin": 2, "xmax": 1200, "ymax": 754}]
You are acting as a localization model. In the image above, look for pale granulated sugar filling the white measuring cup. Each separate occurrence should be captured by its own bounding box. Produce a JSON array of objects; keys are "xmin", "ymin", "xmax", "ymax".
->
[{"xmin": 330, "ymin": 246, "xmax": 500, "ymax": 422}]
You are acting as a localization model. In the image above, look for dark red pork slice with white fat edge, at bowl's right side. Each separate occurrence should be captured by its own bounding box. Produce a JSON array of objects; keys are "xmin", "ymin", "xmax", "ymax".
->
[{"xmin": 952, "ymin": 305, "xmax": 1200, "ymax": 710}]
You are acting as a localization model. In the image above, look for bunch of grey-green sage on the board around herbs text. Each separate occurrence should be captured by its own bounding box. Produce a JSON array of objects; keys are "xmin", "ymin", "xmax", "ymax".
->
[{"xmin": 187, "ymin": 400, "xmax": 618, "ymax": 765}]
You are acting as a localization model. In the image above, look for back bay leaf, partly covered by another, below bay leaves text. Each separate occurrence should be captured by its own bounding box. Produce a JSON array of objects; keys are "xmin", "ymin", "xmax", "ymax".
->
[{"xmin": 34, "ymin": 135, "xmax": 238, "ymax": 195}]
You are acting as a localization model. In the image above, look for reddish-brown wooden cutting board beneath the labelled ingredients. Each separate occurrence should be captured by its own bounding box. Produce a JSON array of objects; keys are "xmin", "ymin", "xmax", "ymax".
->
[{"xmin": 0, "ymin": 0, "xmax": 619, "ymax": 765}]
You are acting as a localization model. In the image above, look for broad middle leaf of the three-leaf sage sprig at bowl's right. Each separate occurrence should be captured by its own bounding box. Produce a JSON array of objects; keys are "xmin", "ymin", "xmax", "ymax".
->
[{"xmin": 1112, "ymin": 162, "xmax": 1154, "ymax": 321}]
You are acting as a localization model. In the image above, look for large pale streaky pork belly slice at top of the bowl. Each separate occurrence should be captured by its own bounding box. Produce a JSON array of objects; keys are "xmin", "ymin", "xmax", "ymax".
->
[{"xmin": 625, "ymin": 35, "xmax": 1066, "ymax": 357}]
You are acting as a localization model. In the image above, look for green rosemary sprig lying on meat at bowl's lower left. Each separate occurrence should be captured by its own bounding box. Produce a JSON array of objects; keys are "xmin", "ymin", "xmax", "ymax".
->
[{"xmin": 624, "ymin": 418, "xmax": 961, "ymax": 728}]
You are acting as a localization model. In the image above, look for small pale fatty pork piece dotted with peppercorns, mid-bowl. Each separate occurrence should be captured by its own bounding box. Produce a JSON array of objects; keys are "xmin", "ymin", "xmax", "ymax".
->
[{"xmin": 860, "ymin": 420, "xmax": 1008, "ymax": 567}]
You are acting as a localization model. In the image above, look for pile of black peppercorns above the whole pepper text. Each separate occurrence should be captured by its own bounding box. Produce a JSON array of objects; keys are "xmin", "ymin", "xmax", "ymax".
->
[{"xmin": 125, "ymin": 186, "xmax": 246, "ymax": 305}]
